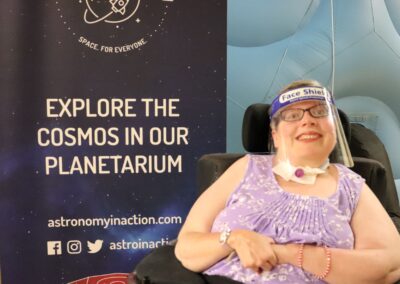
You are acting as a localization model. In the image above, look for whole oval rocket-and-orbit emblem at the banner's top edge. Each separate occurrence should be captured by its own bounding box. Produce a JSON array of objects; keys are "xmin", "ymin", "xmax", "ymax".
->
[{"xmin": 83, "ymin": 0, "xmax": 140, "ymax": 25}]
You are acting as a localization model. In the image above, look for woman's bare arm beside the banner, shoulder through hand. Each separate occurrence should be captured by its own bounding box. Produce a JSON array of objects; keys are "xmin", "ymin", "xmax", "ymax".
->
[{"xmin": 175, "ymin": 157, "xmax": 277, "ymax": 272}]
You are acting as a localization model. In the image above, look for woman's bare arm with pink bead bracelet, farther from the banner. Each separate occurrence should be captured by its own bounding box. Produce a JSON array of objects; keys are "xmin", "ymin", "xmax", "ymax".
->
[{"xmin": 273, "ymin": 185, "xmax": 400, "ymax": 284}]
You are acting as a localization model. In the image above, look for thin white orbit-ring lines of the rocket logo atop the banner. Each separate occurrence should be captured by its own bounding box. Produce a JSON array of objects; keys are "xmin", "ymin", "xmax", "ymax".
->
[{"xmin": 83, "ymin": 0, "xmax": 140, "ymax": 25}]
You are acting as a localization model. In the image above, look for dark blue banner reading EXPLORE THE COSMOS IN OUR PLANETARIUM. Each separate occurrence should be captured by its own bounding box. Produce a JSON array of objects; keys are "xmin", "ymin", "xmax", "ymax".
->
[{"xmin": 0, "ymin": 0, "xmax": 226, "ymax": 284}]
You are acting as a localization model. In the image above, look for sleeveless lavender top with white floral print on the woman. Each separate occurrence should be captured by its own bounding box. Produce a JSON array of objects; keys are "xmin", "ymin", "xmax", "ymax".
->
[{"xmin": 204, "ymin": 155, "xmax": 365, "ymax": 284}]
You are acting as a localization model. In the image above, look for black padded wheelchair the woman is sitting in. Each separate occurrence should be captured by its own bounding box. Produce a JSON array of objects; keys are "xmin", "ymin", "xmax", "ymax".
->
[{"xmin": 135, "ymin": 104, "xmax": 400, "ymax": 284}]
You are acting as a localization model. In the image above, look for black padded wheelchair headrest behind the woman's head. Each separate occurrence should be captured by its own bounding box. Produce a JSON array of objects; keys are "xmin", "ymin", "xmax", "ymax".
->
[{"xmin": 242, "ymin": 103, "xmax": 351, "ymax": 153}]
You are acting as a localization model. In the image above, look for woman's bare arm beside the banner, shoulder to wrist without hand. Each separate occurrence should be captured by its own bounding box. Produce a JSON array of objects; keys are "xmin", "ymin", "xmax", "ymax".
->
[{"xmin": 175, "ymin": 156, "xmax": 248, "ymax": 271}]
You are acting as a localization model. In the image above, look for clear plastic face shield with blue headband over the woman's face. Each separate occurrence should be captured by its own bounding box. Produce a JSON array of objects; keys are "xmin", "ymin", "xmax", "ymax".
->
[{"xmin": 270, "ymin": 87, "xmax": 354, "ymax": 184}]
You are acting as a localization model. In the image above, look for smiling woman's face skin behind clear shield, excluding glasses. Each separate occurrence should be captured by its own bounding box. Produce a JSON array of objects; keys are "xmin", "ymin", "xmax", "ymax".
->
[{"xmin": 272, "ymin": 101, "xmax": 336, "ymax": 167}]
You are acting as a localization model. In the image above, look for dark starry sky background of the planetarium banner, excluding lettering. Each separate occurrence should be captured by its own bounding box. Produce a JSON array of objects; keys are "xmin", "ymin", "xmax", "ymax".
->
[{"xmin": 0, "ymin": 0, "xmax": 226, "ymax": 284}]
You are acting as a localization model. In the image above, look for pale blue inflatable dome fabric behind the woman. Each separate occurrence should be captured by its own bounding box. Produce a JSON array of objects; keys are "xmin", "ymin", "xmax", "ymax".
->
[{"xmin": 227, "ymin": 0, "xmax": 400, "ymax": 191}]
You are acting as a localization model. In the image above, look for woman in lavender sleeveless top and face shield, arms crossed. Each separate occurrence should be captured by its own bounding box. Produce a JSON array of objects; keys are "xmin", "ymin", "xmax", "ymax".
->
[{"xmin": 175, "ymin": 81, "xmax": 400, "ymax": 284}]
